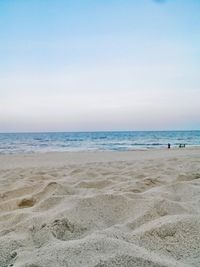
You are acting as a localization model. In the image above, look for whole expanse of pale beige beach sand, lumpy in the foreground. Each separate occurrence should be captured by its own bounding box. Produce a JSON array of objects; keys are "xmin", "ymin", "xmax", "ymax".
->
[{"xmin": 0, "ymin": 148, "xmax": 200, "ymax": 267}]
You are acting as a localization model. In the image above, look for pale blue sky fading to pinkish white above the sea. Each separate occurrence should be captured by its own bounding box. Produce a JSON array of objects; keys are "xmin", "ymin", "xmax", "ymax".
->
[{"xmin": 0, "ymin": 0, "xmax": 200, "ymax": 132}]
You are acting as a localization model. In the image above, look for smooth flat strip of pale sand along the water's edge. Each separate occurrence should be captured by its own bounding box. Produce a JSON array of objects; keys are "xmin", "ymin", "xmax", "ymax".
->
[{"xmin": 0, "ymin": 147, "xmax": 200, "ymax": 169}]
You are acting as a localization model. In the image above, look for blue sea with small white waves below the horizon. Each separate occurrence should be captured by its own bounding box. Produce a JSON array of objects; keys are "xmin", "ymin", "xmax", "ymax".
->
[{"xmin": 0, "ymin": 131, "xmax": 200, "ymax": 154}]
